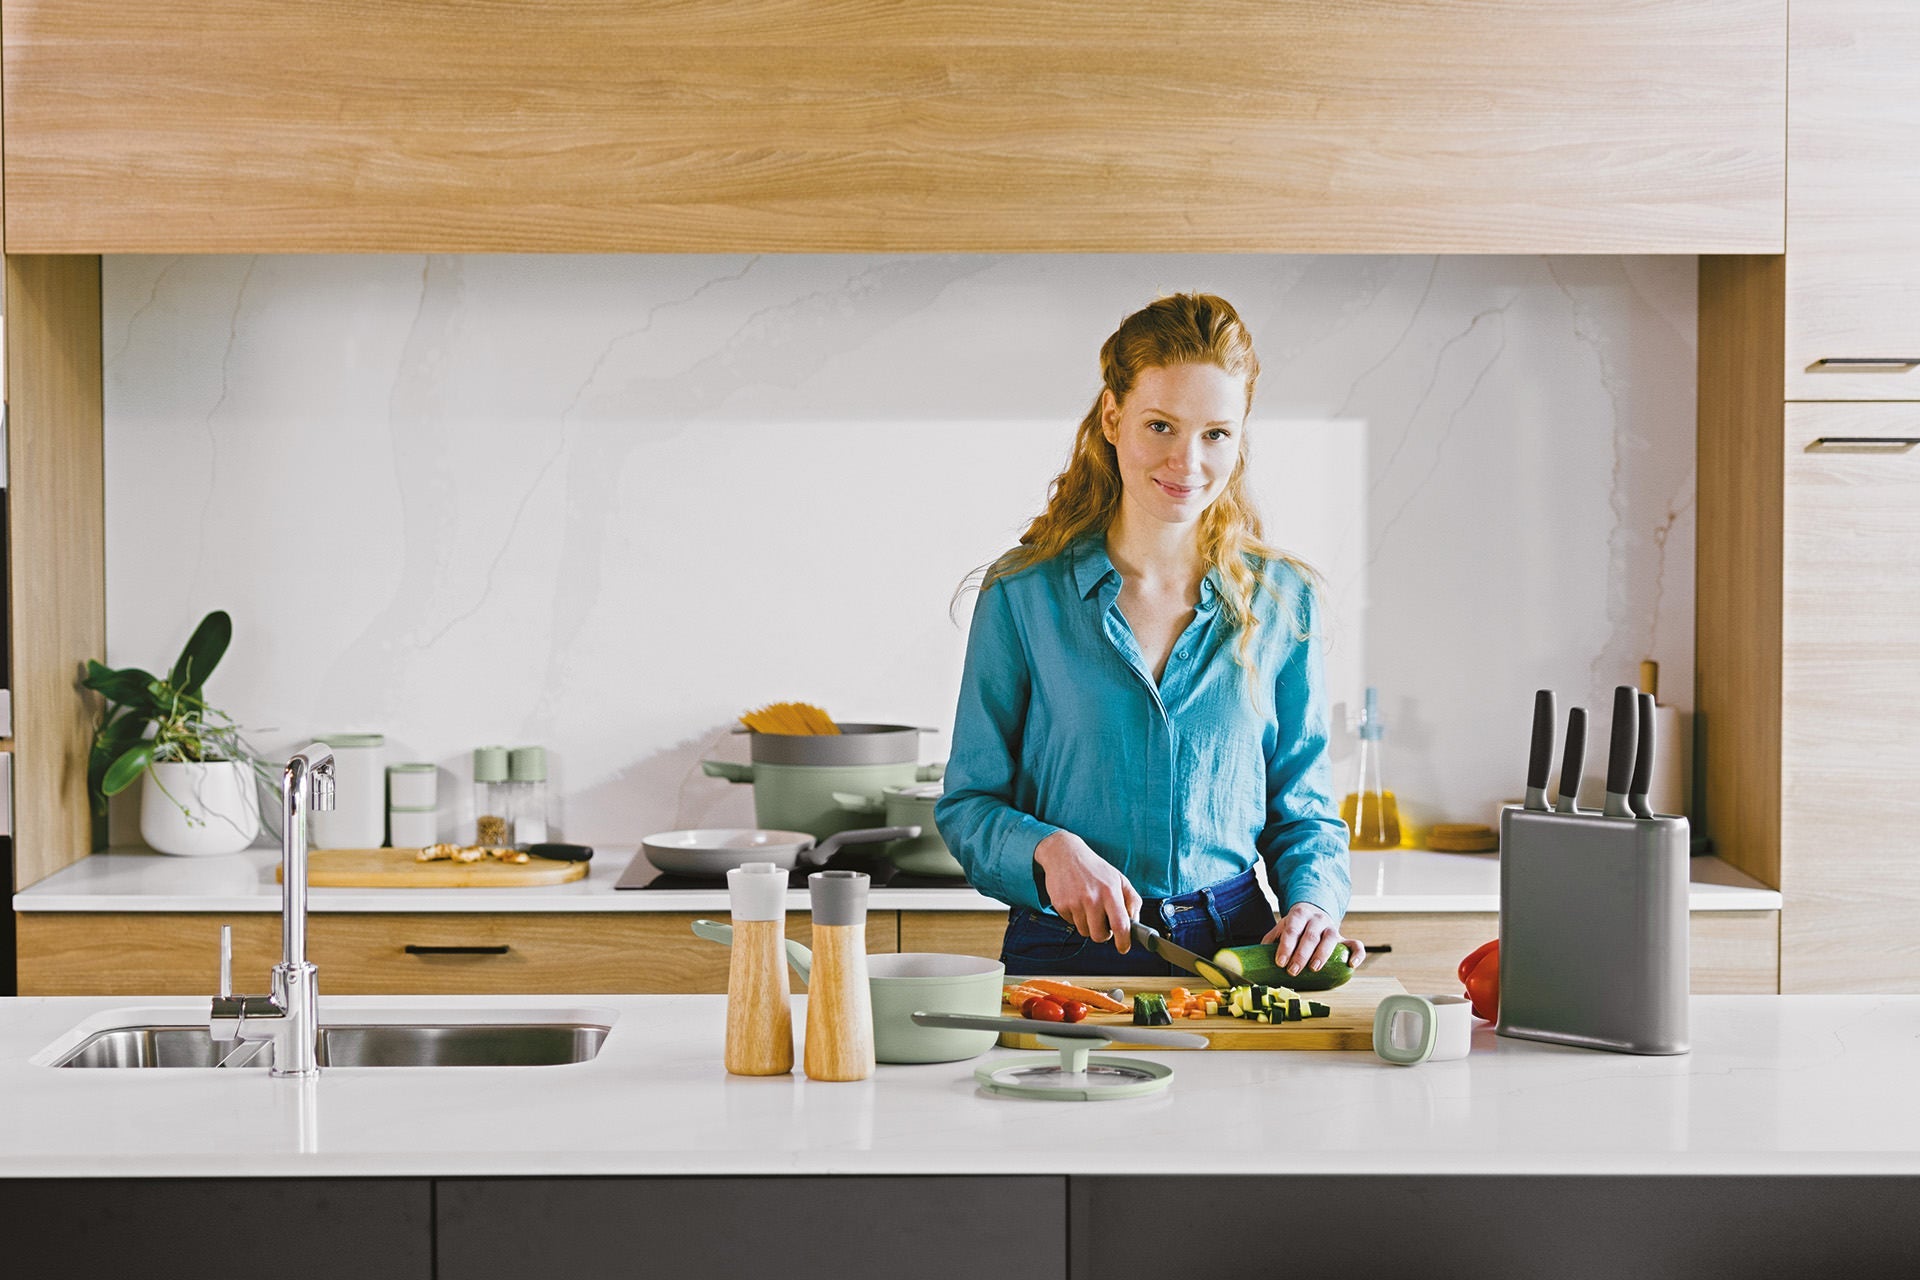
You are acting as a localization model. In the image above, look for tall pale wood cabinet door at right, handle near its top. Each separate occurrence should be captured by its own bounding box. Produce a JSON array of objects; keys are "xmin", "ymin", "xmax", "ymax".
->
[{"xmin": 1780, "ymin": 403, "xmax": 1920, "ymax": 992}]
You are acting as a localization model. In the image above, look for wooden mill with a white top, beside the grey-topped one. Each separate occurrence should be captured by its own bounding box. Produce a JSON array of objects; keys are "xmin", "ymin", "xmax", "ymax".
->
[{"xmin": 726, "ymin": 862, "xmax": 793, "ymax": 1075}]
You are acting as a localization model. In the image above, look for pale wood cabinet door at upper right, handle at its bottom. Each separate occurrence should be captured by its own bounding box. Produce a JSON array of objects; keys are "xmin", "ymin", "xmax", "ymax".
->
[{"xmin": 1786, "ymin": 0, "xmax": 1920, "ymax": 399}]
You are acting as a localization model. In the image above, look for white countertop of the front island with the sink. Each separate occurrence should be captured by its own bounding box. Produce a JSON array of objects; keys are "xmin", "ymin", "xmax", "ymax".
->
[{"xmin": 0, "ymin": 992, "xmax": 1920, "ymax": 1176}]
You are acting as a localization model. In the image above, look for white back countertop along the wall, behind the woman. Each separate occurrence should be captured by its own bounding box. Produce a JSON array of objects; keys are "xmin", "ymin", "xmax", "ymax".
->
[{"xmin": 13, "ymin": 848, "xmax": 1780, "ymax": 913}]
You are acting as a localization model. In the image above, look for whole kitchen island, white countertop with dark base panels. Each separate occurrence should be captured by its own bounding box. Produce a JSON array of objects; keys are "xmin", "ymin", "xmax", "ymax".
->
[{"xmin": 0, "ymin": 997, "xmax": 1920, "ymax": 1278}]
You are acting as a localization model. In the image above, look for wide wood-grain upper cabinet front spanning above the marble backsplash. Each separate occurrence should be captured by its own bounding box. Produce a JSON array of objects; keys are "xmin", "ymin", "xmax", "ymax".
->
[{"xmin": 0, "ymin": 0, "xmax": 1788, "ymax": 253}]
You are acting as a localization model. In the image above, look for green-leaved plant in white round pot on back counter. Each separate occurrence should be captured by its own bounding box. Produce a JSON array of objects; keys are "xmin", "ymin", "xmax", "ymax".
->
[{"xmin": 81, "ymin": 610, "xmax": 265, "ymax": 854}]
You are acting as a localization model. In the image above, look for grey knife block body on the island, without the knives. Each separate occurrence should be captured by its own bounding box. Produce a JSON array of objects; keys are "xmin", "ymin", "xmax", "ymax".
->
[{"xmin": 1496, "ymin": 806, "xmax": 1690, "ymax": 1054}]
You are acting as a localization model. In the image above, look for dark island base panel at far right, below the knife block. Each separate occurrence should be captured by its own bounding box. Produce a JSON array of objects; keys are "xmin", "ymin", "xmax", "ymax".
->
[{"xmin": 1068, "ymin": 1174, "xmax": 1920, "ymax": 1280}]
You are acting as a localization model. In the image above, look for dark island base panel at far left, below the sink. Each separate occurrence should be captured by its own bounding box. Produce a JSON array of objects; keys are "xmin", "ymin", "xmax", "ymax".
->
[{"xmin": 0, "ymin": 1178, "xmax": 434, "ymax": 1280}]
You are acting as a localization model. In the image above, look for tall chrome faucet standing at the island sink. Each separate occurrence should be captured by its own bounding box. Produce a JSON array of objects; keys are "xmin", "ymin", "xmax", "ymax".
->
[{"xmin": 207, "ymin": 743, "xmax": 334, "ymax": 1077}]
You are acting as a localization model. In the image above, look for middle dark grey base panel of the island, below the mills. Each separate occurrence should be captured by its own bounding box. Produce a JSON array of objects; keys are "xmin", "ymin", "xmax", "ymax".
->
[{"xmin": 433, "ymin": 1176, "xmax": 1068, "ymax": 1280}]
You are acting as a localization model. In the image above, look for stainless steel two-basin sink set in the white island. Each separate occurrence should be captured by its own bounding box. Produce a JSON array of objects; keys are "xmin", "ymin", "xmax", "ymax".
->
[{"xmin": 54, "ymin": 1023, "xmax": 607, "ymax": 1069}]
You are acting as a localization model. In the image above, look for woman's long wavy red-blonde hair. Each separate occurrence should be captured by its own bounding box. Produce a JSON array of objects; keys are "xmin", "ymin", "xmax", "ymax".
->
[{"xmin": 954, "ymin": 294, "xmax": 1319, "ymax": 674}]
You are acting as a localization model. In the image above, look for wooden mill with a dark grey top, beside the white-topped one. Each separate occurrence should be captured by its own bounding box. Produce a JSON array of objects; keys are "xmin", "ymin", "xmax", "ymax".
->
[{"xmin": 806, "ymin": 871, "xmax": 874, "ymax": 1080}]
